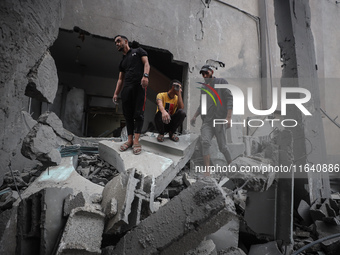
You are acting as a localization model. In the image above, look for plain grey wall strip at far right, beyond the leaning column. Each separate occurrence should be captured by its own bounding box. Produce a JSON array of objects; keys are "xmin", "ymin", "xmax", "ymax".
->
[{"xmin": 310, "ymin": 1, "xmax": 340, "ymax": 163}]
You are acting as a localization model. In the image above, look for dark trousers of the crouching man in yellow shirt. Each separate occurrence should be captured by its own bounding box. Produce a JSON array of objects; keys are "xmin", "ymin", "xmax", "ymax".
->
[{"xmin": 155, "ymin": 109, "xmax": 187, "ymax": 135}]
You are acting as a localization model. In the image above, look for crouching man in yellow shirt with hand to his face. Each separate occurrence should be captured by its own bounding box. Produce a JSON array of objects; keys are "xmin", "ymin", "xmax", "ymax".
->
[{"xmin": 155, "ymin": 80, "xmax": 186, "ymax": 142}]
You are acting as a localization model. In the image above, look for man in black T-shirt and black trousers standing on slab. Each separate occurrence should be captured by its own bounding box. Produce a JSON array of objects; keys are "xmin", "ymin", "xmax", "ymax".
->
[{"xmin": 113, "ymin": 35, "xmax": 150, "ymax": 155}]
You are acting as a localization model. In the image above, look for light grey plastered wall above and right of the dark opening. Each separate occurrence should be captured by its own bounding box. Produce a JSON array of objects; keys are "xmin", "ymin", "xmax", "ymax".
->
[{"xmin": 61, "ymin": 0, "xmax": 261, "ymax": 134}]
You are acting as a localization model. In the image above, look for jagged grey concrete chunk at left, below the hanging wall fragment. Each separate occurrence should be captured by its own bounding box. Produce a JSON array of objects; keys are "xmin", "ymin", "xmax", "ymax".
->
[{"xmin": 21, "ymin": 123, "xmax": 61, "ymax": 166}]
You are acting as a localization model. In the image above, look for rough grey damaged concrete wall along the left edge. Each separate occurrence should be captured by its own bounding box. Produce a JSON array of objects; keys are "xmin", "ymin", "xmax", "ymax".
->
[{"xmin": 0, "ymin": 0, "xmax": 63, "ymax": 184}]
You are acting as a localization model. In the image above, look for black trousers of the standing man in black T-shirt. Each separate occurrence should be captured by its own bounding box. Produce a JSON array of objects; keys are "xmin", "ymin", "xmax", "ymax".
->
[{"xmin": 121, "ymin": 84, "xmax": 146, "ymax": 135}]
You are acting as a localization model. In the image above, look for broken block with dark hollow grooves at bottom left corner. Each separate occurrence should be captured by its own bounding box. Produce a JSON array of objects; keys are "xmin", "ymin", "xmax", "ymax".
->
[{"xmin": 16, "ymin": 188, "xmax": 73, "ymax": 254}]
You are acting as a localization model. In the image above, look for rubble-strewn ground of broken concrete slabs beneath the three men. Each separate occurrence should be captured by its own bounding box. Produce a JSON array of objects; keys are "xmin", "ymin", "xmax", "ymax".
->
[{"xmin": 0, "ymin": 114, "xmax": 340, "ymax": 255}]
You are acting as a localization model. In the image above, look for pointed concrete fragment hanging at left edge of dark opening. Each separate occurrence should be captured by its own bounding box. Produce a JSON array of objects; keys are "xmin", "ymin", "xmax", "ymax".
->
[{"xmin": 25, "ymin": 51, "xmax": 58, "ymax": 104}]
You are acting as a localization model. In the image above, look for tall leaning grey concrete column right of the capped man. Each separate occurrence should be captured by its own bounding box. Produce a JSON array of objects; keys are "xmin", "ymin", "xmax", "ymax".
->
[{"xmin": 274, "ymin": 0, "xmax": 329, "ymax": 203}]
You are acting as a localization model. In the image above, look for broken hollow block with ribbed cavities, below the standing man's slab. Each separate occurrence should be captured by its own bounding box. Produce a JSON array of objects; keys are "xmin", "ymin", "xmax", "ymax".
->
[{"xmin": 102, "ymin": 169, "xmax": 154, "ymax": 234}]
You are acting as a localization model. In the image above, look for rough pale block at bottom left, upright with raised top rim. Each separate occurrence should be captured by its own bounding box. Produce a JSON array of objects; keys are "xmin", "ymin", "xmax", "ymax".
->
[{"xmin": 56, "ymin": 205, "xmax": 105, "ymax": 255}]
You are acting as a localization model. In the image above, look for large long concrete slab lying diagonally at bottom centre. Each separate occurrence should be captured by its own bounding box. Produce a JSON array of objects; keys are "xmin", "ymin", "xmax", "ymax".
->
[{"xmin": 111, "ymin": 179, "xmax": 237, "ymax": 255}]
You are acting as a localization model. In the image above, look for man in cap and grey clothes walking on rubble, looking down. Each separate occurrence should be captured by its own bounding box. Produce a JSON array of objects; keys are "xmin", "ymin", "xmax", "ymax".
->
[{"xmin": 190, "ymin": 65, "xmax": 233, "ymax": 175}]
